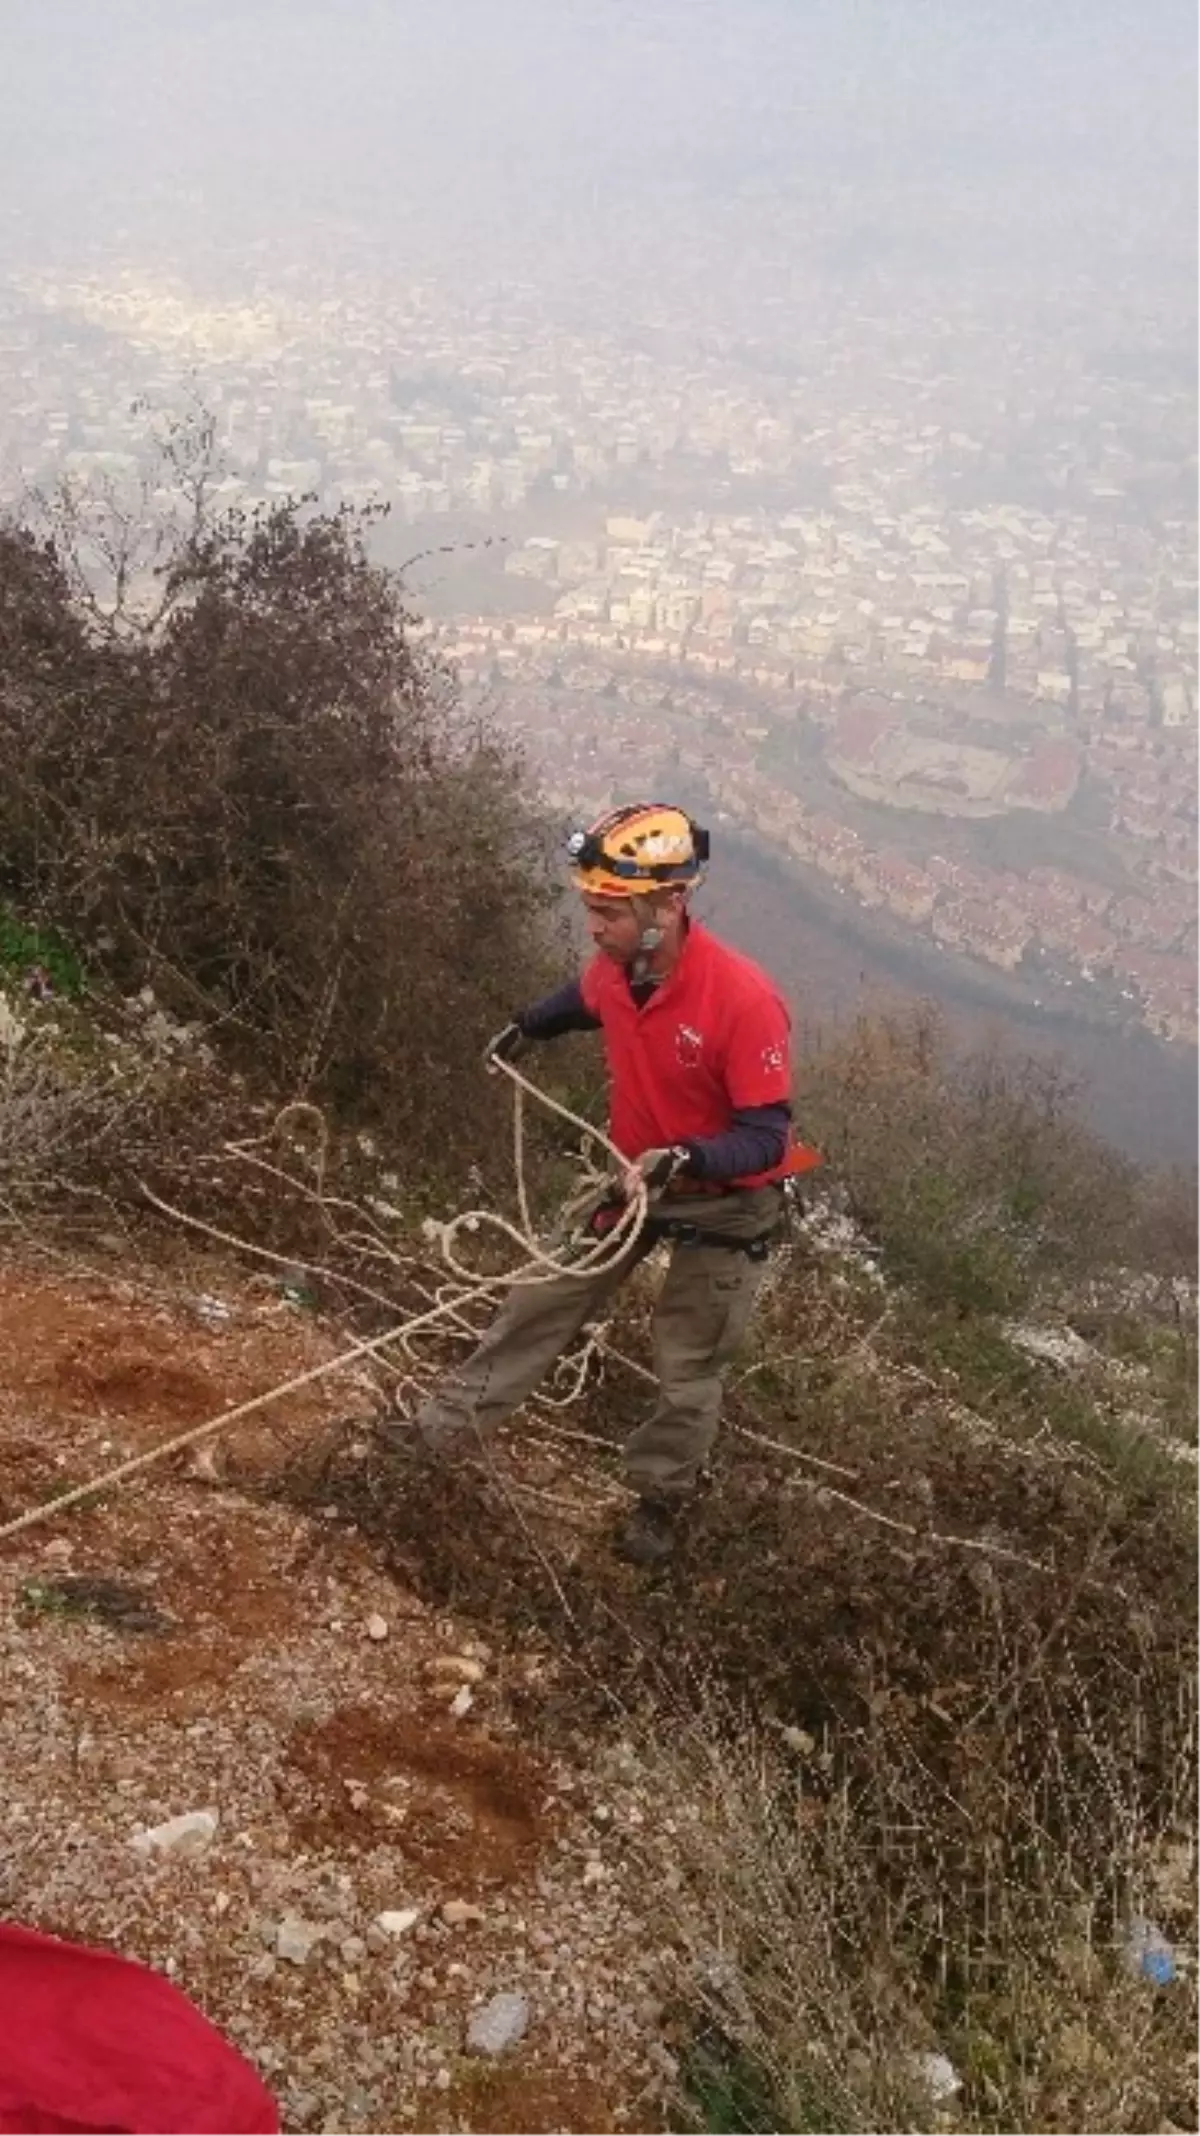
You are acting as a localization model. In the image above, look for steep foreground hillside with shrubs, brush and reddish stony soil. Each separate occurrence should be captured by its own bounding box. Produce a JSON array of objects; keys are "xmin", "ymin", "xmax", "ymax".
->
[{"xmin": 0, "ymin": 484, "xmax": 1200, "ymax": 2136}]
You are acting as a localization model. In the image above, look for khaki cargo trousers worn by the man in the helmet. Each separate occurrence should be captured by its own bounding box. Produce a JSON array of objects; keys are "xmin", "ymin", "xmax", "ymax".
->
[{"xmin": 416, "ymin": 1188, "xmax": 781, "ymax": 1499}]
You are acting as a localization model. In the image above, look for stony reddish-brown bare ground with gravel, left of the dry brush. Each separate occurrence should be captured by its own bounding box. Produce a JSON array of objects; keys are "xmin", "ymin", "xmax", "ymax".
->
[{"xmin": 0, "ymin": 1260, "xmax": 673, "ymax": 2136}]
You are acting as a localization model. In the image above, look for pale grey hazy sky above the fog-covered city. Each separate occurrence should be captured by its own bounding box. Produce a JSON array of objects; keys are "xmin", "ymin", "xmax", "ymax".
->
[{"xmin": 0, "ymin": 0, "xmax": 1200, "ymax": 284}]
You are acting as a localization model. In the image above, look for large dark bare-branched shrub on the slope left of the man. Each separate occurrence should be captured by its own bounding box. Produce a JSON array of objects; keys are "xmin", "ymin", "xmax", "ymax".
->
[{"xmin": 0, "ymin": 484, "xmax": 551, "ymax": 1171}]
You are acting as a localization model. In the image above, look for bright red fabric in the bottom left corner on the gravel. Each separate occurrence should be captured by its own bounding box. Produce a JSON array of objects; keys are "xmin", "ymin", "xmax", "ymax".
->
[{"xmin": 0, "ymin": 1925, "xmax": 280, "ymax": 2136}]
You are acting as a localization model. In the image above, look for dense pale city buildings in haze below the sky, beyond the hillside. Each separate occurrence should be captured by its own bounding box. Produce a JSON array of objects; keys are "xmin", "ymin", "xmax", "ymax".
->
[{"xmin": 0, "ymin": 212, "xmax": 1200, "ymax": 1045}]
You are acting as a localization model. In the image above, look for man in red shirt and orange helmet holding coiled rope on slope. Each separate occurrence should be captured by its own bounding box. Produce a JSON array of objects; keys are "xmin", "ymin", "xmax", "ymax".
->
[{"xmin": 405, "ymin": 803, "xmax": 811, "ymax": 1564}]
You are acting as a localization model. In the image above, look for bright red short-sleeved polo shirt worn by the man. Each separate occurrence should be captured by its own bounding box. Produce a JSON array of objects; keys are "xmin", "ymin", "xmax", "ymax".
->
[{"xmin": 581, "ymin": 923, "xmax": 792, "ymax": 1188}]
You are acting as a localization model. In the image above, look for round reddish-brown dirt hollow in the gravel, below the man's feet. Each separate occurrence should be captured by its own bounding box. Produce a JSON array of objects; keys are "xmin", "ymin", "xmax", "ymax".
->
[{"xmin": 279, "ymin": 1707, "xmax": 547, "ymax": 1892}]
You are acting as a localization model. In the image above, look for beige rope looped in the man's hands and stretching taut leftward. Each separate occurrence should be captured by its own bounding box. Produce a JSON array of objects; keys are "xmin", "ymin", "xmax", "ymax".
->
[{"xmin": 0, "ymin": 1059, "xmax": 649, "ymax": 1542}]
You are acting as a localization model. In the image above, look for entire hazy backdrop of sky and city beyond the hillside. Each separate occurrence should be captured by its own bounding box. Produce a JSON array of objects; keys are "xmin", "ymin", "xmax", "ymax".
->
[{"xmin": 0, "ymin": 0, "xmax": 1200, "ymax": 1153}]
